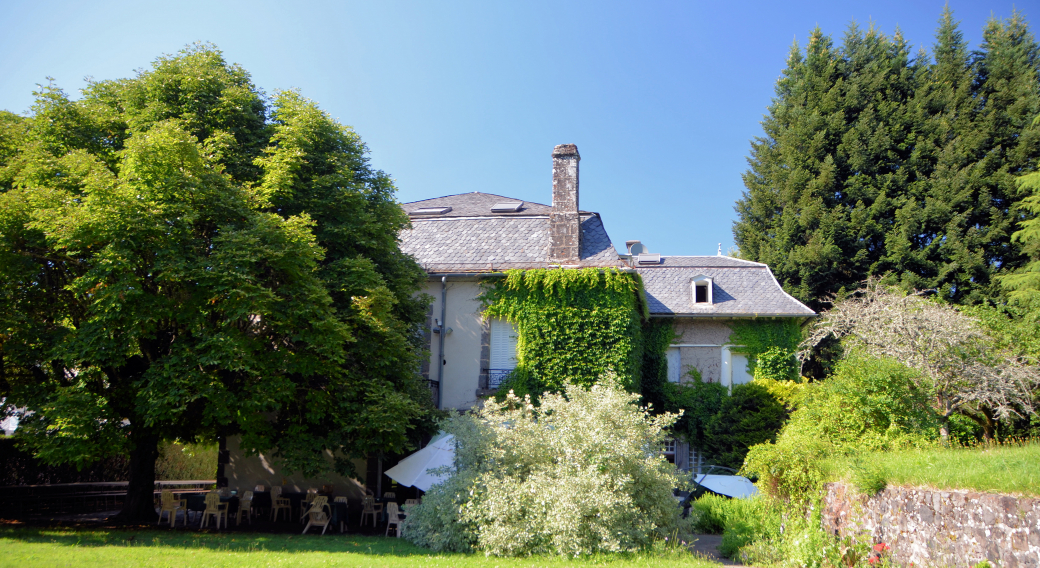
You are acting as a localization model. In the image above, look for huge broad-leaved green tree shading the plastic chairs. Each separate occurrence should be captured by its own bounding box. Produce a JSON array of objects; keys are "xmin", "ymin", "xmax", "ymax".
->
[{"xmin": 0, "ymin": 45, "xmax": 431, "ymax": 521}]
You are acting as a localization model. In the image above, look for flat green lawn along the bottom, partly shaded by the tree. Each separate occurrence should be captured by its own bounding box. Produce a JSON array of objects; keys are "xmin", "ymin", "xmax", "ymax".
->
[{"xmin": 0, "ymin": 526, "xmax": 718, "ymax": 568}]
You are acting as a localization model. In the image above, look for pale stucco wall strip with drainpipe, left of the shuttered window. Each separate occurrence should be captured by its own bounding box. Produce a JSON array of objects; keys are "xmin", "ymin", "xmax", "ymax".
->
[{"xmin": 425, "ymin": 278, "xmax": 484, "ymax": 410}]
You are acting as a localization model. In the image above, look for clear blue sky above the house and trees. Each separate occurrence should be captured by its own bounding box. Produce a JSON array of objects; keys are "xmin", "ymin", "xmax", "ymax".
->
[{"xmin": 0, "ymin": 0, "xmax": 1027, "ymax": 255}]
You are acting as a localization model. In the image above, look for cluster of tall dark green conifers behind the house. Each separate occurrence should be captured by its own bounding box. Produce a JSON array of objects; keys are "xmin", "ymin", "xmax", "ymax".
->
[{"xmin": 733, "ymin": 9, "xmax": 1040, "ymax": 311}]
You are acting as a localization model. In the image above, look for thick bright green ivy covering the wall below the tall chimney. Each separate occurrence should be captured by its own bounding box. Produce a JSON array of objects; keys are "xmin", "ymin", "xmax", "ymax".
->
[{"xmin": 482, "ymin": 268, "xmax": 649, "ymax": 395}]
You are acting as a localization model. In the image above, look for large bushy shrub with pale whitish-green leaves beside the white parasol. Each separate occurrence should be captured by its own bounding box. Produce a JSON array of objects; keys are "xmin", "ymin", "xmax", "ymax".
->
[{"xmin": 405, "ymin": 380, "xmax": 682, "ymax": 557}]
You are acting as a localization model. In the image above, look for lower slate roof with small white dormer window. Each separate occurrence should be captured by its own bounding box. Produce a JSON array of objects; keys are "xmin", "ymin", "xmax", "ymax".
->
[{"xmin": 635, "ymin": 256, "xmax": 815, "ymax": 317}]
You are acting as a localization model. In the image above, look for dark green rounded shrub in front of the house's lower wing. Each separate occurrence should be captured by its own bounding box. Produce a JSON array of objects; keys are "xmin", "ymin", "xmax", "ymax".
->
[{"xmin": 703, "ymin": 383, "xmax": 787, "ymax": 469}]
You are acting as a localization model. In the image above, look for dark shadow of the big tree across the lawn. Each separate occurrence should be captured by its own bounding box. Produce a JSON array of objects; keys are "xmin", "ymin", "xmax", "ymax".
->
[{"xmin": 0, "ymin": 526, "xmax": 430, "ymax": 557}]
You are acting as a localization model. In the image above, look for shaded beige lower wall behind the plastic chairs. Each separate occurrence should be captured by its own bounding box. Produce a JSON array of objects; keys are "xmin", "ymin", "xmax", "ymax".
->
[{"xmin": 225, "ymin": 436, "xmax": 365, "ymax": 499}]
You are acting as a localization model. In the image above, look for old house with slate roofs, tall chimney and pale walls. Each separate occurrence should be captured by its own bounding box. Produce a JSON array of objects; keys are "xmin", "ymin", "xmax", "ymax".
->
[{"xmin": 229, "ymin": 145, "xmax": 814, "ymax": 491}]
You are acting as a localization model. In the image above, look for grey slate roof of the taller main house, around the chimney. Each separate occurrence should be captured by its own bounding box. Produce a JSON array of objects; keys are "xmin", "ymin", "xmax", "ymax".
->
[{"xmin": 400, "ymin": 192, "xmax": 623, "ymax": 273}]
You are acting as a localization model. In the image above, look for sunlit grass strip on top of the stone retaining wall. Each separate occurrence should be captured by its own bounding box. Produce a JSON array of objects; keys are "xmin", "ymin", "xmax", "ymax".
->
[{"xmin": 827, "ymin": 443, "xmax": 1040, "ymax": 496}]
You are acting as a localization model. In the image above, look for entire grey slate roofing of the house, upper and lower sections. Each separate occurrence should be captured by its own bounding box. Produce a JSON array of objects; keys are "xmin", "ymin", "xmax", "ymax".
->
[{"xmin": 400, "ymin": 191, "xmax": 815, "ymax": 317}]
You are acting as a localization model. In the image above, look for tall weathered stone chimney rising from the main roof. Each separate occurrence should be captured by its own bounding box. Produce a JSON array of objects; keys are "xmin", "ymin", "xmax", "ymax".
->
[{"xmin": 549, "ymin": 144, "xmax": 581, "ymax": 264}]
